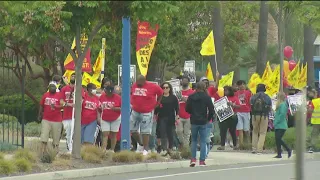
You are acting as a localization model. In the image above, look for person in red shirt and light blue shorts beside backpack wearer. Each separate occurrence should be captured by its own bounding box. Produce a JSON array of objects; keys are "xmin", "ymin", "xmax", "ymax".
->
[{"xmin": 235, "ymin": 80, "xmax": 252, "ymax": 147}]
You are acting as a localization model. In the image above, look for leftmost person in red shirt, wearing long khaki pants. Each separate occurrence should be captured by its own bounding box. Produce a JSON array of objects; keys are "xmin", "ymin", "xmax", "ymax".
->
[{"xmin": 38, "ymin": 83, "xmax": 62, "ymax": 153}]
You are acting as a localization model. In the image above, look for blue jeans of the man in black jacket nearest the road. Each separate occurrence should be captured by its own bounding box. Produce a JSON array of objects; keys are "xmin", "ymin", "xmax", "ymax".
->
[{"xmin": 191, "ymin": 124, "xmax": 207, "ymax": 161}]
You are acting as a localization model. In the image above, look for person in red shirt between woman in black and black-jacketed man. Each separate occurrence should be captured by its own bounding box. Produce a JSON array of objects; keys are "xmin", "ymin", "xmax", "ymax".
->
[{"xmin": 176, "ymin": 76, "xmax": 194, "ymax": 147}]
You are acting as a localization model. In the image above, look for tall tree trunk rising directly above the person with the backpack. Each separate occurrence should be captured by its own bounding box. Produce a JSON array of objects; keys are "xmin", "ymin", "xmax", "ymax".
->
[{"xmin": 256, "ymin": 1, "xmax": 269, "ymax": 76}]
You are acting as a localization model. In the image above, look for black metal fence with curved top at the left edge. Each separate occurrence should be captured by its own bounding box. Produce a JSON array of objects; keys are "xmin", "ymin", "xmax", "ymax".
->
[{"xmin": 0, "ymin": 52, "xmax": 26, "ymax": 147}]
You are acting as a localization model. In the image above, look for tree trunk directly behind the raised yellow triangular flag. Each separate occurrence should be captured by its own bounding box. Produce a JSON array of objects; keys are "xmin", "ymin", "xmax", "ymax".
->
[{"xmin": 210, "ymin": 2, "xmax": 225, "ymax": 78}]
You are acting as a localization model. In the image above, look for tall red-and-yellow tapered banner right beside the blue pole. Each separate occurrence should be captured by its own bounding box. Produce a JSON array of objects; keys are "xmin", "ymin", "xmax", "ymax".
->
[{"xmin": 136, "ymin": 21, "xmax": 159, "ymax": 76}]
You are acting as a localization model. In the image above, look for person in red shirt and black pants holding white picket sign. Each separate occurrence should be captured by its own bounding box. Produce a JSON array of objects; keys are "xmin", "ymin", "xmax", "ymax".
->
[{"xmin": 218, "ymin": 86, "xmax": 240, "ymax": 150}]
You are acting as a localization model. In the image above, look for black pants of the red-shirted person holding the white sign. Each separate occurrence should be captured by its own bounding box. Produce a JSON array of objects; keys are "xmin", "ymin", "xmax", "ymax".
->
[{"xmin": 219, "ymin": 116, "xmax": 238, "ymax": 147}]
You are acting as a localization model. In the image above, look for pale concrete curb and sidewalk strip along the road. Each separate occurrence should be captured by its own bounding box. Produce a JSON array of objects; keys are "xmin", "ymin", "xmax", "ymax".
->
[{"xmin": 1, "ymin": 152, "xmax": 320, "ymax": 180}]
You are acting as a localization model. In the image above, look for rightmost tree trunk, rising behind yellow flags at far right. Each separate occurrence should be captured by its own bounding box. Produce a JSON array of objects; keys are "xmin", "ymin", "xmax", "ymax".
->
[{"xmin": 303, "ymin": 25, "xmax": 316, "ymax": 87}]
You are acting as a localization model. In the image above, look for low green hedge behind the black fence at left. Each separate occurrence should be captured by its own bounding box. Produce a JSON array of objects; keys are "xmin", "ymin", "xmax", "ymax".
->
[{"xmin": 0, "ymin": 94, "xmax": 41, "ymax": 124}]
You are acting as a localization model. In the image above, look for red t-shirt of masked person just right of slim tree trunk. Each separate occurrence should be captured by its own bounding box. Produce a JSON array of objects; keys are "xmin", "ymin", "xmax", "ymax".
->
[{"xmin": 81, "ymin": 93, "xmax": 100, "ymax": 125}]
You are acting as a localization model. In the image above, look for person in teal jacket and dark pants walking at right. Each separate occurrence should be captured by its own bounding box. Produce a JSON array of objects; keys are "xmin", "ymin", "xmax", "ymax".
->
[{"xmin": 273, "ymin": 92, "xmax": 292, "ymax": 158}]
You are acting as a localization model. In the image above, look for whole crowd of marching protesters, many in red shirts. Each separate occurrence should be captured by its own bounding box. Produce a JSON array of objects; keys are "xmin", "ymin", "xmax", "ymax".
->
[{"xmin": 39, "ymin": 73, "xmax": 320, "ymax": 167}]
